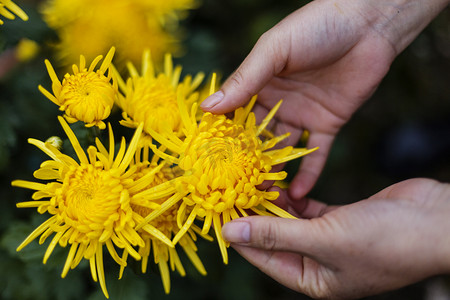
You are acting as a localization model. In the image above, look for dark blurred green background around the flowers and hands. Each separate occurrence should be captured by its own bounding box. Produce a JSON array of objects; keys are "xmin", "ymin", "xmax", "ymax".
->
[{"xmin": 0, "ymin": 0, "xmax": 450, "ymax": 300}]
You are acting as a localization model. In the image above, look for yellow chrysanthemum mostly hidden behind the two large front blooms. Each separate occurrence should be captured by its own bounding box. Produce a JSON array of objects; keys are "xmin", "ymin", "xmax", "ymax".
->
[{"xmin": 120, "ymin": 146, "xmax": 210, "ymax": 293}]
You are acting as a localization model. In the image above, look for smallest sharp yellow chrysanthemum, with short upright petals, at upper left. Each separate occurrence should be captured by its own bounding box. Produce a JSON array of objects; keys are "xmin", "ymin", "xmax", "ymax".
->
[{"xmin": 39, "ymin": 47, "xmax": 118, "ymax": 129}]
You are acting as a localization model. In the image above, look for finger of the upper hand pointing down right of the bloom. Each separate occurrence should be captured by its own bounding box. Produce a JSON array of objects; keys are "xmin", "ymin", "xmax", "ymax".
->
[{"xmin": 289, "ymin": 133, "xmax": 334, "ymax": 200}]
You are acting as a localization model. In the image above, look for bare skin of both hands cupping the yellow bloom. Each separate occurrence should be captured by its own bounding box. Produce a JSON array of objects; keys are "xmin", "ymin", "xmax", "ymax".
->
[{"xmin": 202, "ymin": 0, "xmax": 450, "ymax": 299}]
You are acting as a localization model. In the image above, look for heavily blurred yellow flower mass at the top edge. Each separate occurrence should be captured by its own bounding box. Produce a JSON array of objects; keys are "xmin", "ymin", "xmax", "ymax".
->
[{"xmin": 42, "ymin": 0, "xmax": 196, "ymax": 69}]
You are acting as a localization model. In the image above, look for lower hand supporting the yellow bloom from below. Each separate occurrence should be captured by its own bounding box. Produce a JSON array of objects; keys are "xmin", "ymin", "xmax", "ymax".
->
[{"xmin": 222, "ymin": 179, "xmax": 450, "ymax": 299}]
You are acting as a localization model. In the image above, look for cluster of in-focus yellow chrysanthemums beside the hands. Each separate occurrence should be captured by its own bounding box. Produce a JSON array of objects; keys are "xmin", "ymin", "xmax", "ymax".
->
[{"xmin": 12, "ymin": 48, "xmax": 315, "ymax": 297}]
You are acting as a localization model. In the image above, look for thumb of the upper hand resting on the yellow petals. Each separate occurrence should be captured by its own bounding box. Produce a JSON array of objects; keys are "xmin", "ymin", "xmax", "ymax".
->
[{"xmin": 201, "ymin": 27, "xmax": 289, "ymax": 114}]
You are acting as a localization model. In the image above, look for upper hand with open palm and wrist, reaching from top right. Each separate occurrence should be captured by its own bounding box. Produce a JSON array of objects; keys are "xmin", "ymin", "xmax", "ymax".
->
[{"xmin": 202, "ymin": 0, "xmax": 448, "ymax": 200}]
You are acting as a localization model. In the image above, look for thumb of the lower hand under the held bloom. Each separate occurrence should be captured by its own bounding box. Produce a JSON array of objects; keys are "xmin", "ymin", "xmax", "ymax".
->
[{"xmin": 222, "ymin": 216, "xmax": 328, "ymax": 257}]
